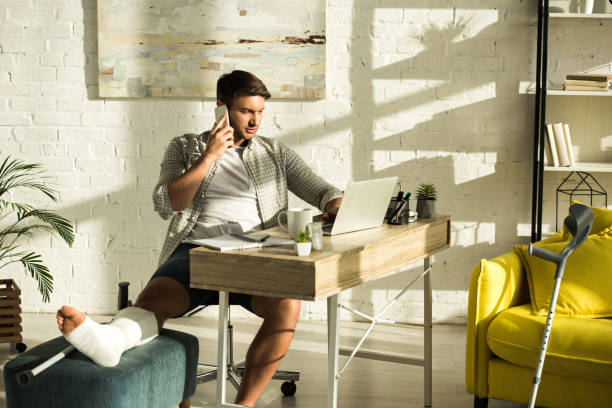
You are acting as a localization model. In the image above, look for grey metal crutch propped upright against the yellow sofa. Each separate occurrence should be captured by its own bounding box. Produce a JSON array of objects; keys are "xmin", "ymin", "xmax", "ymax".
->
[{"xmin": 529, "ymin": 204, "xmax": 593, "ymax": 408}]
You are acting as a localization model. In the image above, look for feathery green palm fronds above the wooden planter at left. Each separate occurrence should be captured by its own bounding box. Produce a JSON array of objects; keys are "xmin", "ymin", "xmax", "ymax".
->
[{"xmin": 0, "ymin": 156, "xmax": 74, "ymax": 302}]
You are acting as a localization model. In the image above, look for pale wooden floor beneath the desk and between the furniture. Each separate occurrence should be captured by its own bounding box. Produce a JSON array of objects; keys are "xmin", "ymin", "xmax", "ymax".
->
[{"xmin": 0, "ymin": 314, "xmax": 524, "ymax": 408}]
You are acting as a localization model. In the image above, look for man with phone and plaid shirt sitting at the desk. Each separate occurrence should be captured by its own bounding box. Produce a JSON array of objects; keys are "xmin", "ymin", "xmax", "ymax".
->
[{"xmin": 57, "ymin": 71, "xmax": 342, "ymax": 407}]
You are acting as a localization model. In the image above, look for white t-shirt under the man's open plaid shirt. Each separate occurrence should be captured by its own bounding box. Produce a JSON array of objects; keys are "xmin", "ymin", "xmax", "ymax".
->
[{"xmin": 187, "ymin": 147, "xmax": 262, "ymax": 239}]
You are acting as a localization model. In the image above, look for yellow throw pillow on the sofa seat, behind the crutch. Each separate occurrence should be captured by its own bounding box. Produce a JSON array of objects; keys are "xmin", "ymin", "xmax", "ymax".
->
[{"xmin": 514, "ymin": 228, "xmax": 612, "ymax": 317}]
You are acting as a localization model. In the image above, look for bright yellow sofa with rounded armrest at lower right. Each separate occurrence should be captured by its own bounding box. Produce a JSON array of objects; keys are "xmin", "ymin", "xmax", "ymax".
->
[{"xmin": 465, "ymin": 247, "xmax": 612, "ymax": 408}]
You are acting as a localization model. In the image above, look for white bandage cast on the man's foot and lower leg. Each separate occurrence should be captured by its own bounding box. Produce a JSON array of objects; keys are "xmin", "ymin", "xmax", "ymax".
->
[{"xmin": 64, "ymin": 307, "xmax": 158, "ymax": 367}]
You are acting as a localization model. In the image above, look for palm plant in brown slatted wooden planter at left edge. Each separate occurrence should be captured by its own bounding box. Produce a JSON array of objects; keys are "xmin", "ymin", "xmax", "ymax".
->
[{"xmin": 0, "ymin": 156, "xmax": 74, "ymax": 351}]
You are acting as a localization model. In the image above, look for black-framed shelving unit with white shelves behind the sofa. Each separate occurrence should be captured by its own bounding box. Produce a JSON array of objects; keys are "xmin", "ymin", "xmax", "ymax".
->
[{"xmin": 526, "ymin": 0, "xmax": 612, "ymax": 242}]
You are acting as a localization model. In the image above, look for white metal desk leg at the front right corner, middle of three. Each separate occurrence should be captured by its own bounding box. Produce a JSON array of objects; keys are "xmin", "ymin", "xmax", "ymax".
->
[{"xmin": 327, "ymin": 295, "xmax": 340, "ymax": 408}]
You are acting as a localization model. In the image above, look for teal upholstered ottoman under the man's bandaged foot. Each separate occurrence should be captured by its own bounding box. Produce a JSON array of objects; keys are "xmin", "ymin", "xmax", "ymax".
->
[{"xmin": 4, "ymin": 329, "xmax": 198, "ymax": 408}]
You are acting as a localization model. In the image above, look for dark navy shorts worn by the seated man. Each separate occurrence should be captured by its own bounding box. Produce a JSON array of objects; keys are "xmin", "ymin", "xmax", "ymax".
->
[{"xmin": 151, "ymin": 244, "xmax": 253, "ymax": 312}]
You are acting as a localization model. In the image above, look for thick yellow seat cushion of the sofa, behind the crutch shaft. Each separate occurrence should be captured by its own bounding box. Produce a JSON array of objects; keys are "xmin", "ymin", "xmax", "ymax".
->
[{"xmin": 487, "ymin": 304, "xmax": 612, "ymax": 383}]
